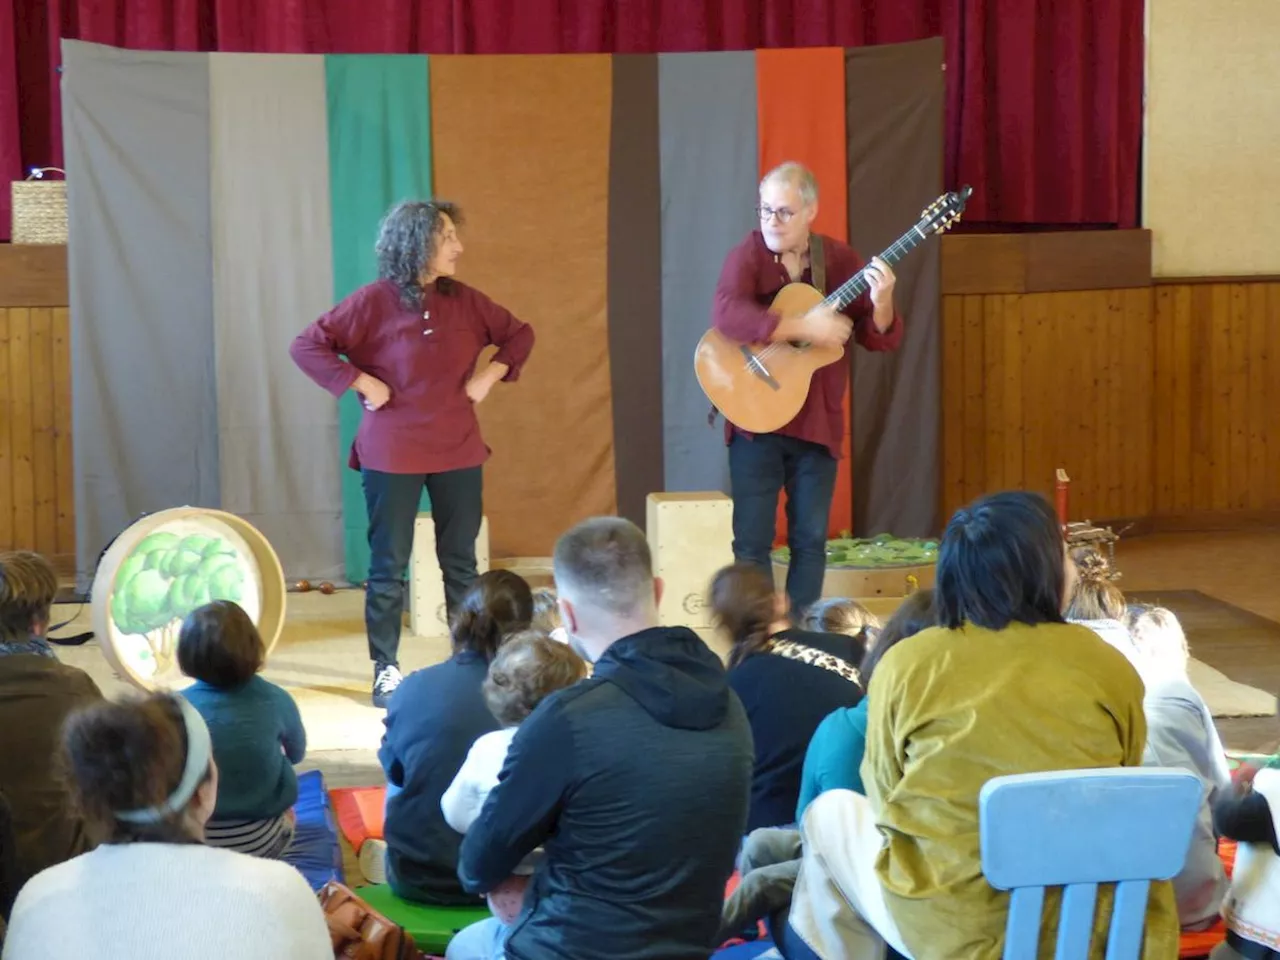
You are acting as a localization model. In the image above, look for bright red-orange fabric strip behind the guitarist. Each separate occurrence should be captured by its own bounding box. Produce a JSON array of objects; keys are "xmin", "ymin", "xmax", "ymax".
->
[{"xmin": 755, "ymin": 47, "xmax": 854, "ymax": 543}]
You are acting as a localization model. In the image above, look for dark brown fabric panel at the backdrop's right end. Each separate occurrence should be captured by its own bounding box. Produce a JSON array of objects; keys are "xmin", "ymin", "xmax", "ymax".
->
[{"xmin": 845, "ymin": 38, "xmax": 945, "ymax": 536}]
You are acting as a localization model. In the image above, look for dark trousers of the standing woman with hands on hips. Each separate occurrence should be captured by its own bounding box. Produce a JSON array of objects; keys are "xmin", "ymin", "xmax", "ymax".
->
[{"xmin": 362, "ymin": 467, "xmax": 484, "ymax": 666}]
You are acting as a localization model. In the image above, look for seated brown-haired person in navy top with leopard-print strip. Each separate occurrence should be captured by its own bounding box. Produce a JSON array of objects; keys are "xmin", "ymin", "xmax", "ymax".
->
[{"xmin": 709, "ymin": 563, "xmax": 865, "ymax": 831}]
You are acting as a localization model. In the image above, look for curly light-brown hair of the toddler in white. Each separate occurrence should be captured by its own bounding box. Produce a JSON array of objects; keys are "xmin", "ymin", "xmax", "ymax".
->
[{"xmin": 484, "ymin": 630, "xmax": 586, "ymax": 727}]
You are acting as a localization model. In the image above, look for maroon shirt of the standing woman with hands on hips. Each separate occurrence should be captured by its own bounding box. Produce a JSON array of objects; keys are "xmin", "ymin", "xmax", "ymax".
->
[{"xmin": 289, "ymin": 280, "xmax": 534, "ymax": 474}]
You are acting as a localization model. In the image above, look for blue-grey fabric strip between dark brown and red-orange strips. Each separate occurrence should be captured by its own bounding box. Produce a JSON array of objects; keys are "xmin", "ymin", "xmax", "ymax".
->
[{"xmin": 658, "ymin": 51, "xmax": 759, "ymax": 493}]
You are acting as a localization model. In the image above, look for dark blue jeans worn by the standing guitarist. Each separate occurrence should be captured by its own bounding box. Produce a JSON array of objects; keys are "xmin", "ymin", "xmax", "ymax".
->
[{"xmin": 728, "ymin": 434, "xmax": 836, "ymax": 617}]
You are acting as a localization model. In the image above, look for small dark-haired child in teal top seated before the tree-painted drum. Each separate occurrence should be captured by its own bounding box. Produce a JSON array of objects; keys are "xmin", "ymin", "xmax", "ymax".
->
[{"xmin": 178, "ymin": 600, "xmax": 307, "ymax": 859}]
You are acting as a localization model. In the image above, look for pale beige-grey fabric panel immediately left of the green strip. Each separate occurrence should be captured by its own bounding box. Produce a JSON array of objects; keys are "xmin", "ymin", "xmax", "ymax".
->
[{"xmin": 209, "ymin": 54, "xmax": 343, "ymax": 580}]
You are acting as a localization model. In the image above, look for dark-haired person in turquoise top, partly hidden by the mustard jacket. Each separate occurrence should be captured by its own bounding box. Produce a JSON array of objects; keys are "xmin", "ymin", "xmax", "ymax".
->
[{"xmin": 721, "ymin": 590, "xmax": 934, "ymax": 940}]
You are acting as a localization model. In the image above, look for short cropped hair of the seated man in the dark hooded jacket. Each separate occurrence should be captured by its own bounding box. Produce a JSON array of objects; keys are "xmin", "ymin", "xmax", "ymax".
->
[{"xmin": 552, "ymin": 517, "xmax": 653, "ymax": 616}]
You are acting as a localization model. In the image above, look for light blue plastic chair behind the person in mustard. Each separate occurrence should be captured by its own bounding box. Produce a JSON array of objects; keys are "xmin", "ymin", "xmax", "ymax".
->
[{"xmin": 978, "ymin": 767, "xmax": 1202, "ymax": 960}]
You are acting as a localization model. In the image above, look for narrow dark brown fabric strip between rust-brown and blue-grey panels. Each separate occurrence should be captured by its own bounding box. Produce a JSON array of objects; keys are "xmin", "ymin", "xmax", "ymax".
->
[{"xmin": 609, "ymin": 54, "xmax": 663, "ymax": 527}]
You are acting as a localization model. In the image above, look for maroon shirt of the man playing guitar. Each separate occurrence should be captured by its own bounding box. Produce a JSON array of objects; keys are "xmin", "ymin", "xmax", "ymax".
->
[{"xmin": 712, "ymin": 230, "xmax": 902, "ymax": 460}]
